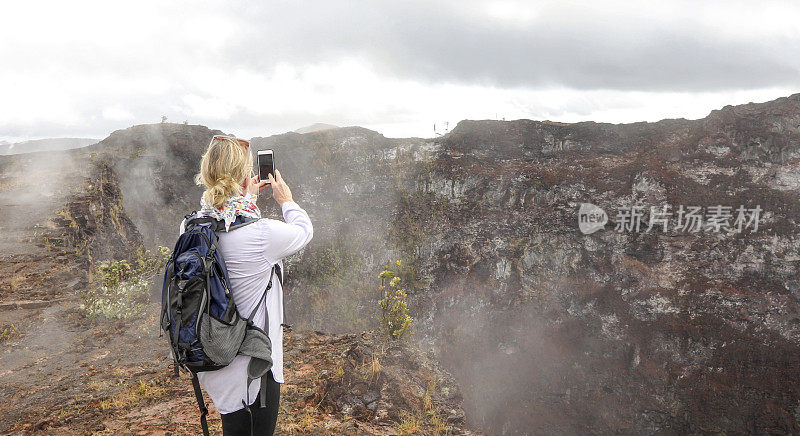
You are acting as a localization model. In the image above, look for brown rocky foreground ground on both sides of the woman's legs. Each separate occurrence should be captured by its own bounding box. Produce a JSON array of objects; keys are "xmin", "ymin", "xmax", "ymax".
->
[{"xmin": 0, "ymin": 298, "xmax": 471, "ymax": 435}]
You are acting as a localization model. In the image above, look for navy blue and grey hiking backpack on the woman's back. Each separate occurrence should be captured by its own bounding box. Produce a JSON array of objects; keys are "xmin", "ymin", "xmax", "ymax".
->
[{"xmin": 160, "ymin": 212, "xmax": 288, "ymax": 436}]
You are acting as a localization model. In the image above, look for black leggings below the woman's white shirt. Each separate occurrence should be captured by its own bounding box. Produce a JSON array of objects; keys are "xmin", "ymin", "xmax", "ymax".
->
[{"xmin": 222, "ymin": 370, "xmax": 281, "ymax": 436}]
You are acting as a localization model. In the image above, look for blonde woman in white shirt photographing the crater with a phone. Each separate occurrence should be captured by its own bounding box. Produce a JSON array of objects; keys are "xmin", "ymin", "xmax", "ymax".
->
[{"xmin": 180, "ymin": 136, "xmax": 314, "ymax": 436}]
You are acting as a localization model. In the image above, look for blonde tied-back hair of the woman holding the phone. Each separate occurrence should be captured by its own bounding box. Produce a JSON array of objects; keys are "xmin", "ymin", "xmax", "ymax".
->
[{"xmin": 194, "ymin": 138, "xmax": 253, "ymax": 207}]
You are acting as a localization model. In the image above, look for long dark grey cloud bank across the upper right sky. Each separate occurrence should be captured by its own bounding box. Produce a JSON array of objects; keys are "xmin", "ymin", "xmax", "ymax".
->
[{"xmin": 226, "ymin": 1, "xmax": 800, "ymax": 91}]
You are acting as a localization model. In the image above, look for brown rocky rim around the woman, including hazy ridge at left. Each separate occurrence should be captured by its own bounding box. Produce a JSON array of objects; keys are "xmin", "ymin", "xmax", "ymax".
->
[{"xmin": 0, "ymin": 124, "xmax": 474, "ymax": 435}]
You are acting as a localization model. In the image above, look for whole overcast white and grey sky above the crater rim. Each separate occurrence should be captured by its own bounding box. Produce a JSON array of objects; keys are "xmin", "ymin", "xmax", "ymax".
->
[{"xmin": 0, "ymin": 0, "xmax": 800, "ymax": 141}]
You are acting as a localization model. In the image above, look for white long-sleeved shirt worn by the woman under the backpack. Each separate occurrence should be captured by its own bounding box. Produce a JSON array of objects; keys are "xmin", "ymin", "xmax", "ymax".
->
[{"xmin": 180, "ymin": 201, "xmax": 314, "ymax": 413}]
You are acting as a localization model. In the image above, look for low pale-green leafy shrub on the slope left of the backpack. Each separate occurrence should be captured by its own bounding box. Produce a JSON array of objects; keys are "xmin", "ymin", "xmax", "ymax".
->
[{"xmin": 80, "ymin": 247, "xmax": 170, "ymax": 319}]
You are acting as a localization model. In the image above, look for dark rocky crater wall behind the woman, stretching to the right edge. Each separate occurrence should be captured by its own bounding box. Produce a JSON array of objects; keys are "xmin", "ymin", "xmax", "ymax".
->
[{"xmin": 0, "ymin": 94, "xmax": 800, "ymax": 434}]
